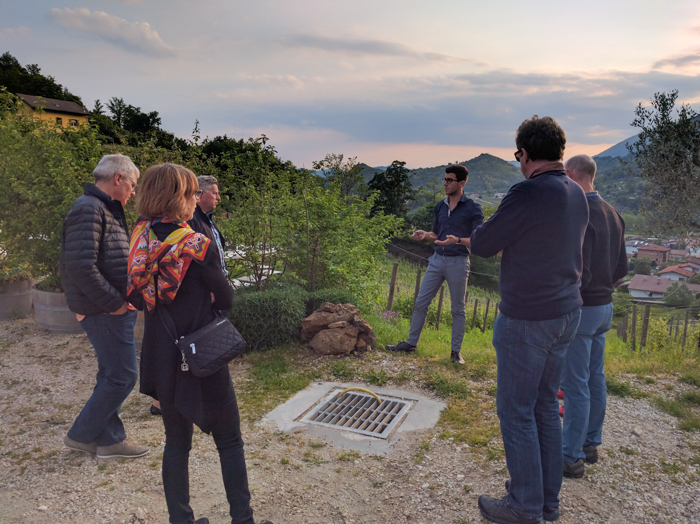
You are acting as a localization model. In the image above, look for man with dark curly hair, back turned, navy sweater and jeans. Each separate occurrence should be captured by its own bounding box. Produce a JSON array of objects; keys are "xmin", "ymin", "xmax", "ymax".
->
[{"xmin": 471, "ymin": 116, "xmax": 588, "ymax": 524}]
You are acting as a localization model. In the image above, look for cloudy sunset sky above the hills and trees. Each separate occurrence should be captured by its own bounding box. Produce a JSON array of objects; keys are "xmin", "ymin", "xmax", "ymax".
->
[{"xmin": 0, "ymin": 0, "xmax": 700, "ymax": 167}]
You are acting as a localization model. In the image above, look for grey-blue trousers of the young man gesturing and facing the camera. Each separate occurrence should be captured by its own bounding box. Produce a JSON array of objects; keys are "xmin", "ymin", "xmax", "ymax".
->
[{"xmin": 406, "ymin": 253, "xmax": 469, "ymax": 351}]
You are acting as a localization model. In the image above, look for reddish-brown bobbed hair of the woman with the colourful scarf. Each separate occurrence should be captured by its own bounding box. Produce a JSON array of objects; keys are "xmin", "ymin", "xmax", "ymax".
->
[{"xmin": 136, "ymin": 164, "xmax": 199, "ymax": 221}]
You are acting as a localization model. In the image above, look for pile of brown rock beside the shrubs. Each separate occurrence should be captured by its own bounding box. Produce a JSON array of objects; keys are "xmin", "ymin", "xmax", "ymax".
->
[{"xmin": 301, "ymin": 302, "xmax": 377, "ymax": 355}]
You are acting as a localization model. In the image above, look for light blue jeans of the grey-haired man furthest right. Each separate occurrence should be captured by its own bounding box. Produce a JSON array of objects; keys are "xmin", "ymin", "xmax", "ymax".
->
[{"xmin": 561, "ymin": 304, "xmax": 613, "ymax": 464}]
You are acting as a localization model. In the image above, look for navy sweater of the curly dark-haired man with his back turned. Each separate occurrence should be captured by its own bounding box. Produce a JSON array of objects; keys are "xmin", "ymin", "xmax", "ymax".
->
[{"xmin": 471, "ymin": 171, "xmax": 588, "ymax": 320}]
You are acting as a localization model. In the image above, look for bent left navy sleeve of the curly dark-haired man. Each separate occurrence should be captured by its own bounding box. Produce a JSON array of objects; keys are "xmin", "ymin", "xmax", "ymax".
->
[{"xmin": 471, "ymin": 188, "xmax": 528, "ymax": 258}]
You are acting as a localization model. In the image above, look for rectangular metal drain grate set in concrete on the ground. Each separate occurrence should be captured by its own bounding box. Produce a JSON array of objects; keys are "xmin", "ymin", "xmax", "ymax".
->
[{"xmin": 302, "ymin": 390, "xmax": 413, "ymax": 438}]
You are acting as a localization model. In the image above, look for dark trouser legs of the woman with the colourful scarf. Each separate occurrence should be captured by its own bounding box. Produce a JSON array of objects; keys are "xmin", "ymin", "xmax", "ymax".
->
[{"xmin": 160, "ymin": 394, "xmax": 254, "ymax": 524}]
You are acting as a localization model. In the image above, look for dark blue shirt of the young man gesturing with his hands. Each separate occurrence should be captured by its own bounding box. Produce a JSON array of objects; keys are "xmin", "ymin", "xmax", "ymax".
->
[{"xmin": 433, "ymin": 193, "xmax": 484, "ymax": 257}]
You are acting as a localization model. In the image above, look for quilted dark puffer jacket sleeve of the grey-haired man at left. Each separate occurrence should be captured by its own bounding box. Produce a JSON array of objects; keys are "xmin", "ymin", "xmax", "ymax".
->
[{"xmin": 63, "ymin": 205, "xmax": 124, "ymax": 313}]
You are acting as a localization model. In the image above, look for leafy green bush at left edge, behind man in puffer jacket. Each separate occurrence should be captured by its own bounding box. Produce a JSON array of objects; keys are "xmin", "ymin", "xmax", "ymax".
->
[{"xmin": 0, "ymin": 92, "xmax": 102, "ymax": 286}]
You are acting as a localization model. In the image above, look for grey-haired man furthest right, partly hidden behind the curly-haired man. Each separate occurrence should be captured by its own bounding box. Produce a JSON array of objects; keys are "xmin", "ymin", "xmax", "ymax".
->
[{"xmin": 561, "ymin": 155, "xmax": 627, "ymax": 478}]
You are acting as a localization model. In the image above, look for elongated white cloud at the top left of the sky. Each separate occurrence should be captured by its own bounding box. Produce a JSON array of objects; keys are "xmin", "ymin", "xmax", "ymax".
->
[{"xmin": 49, "ymin": 7, "xmax": 175, "ymax": 56}]
